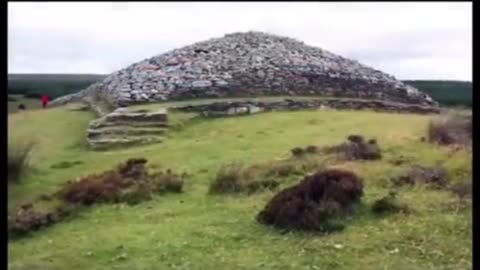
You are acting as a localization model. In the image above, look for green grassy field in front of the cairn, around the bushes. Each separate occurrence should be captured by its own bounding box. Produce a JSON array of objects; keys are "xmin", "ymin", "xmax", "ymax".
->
[{"xmin": 8, "ymin": 104, "xmax": 472, "ymax": 270}]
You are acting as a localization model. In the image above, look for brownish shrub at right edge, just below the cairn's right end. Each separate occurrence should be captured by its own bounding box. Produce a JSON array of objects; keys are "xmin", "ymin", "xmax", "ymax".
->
[{"xmin": 428, "ymin": 116, "xmax": 472, "ymax": 145}]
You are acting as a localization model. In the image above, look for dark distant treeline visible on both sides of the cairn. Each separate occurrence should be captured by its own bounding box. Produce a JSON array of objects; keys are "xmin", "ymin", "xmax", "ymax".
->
[{"xmin": 8, "ymin": 74, "xmax": 472, "ymax": 107}]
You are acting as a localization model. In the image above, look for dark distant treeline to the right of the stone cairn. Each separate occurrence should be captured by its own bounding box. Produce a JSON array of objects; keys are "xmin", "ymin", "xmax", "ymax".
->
[{"xmin": 404, "ymin": 81, "xmax": 473, "ymax": 107}]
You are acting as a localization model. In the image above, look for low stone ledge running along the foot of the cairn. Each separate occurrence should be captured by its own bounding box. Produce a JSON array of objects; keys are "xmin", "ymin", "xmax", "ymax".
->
[{"xmin": 175, "ymin": 99, "xmax": 440, "ymax": 117}]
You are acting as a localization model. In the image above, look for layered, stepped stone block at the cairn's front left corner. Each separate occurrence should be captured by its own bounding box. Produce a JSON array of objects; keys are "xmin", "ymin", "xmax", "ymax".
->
[{"xmin": 87, "ymin": 108, "xmax": 167, "ymax": 150}]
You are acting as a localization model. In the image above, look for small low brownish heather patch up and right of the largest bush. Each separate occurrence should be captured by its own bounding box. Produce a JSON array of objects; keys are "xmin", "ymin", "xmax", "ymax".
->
[{"xmin": 391, "ymin": 165, "xmax": 448, "ymax": 187}]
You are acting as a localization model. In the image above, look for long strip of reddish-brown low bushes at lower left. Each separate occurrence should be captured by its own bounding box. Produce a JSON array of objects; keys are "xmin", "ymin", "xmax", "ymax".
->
[{"xmin": 9, "ymin": 159, "xmax": 186, "ymax": 238}]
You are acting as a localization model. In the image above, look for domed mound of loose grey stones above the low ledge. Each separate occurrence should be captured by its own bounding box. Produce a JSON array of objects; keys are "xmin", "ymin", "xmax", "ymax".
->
[{"xmin": 50, "ymin": 32, "xmax": 437, "ymax": 107}]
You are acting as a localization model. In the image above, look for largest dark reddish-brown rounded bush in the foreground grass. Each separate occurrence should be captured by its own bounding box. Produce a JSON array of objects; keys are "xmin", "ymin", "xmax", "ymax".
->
[{"xmin": 257, "ymin": 169, "xmax": 363, "ymax": 231}]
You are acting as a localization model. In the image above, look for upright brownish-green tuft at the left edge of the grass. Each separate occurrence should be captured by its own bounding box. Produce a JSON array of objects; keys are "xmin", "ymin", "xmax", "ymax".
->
[{"xmin": 7, "ymin": 140, "xmax": 34, "ymax": 182}]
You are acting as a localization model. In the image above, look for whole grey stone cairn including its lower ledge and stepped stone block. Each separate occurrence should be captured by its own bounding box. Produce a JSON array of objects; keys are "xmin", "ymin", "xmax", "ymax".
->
[{"xmin": 51, "ymin": 32, "xmax": 438, "ymax": 149}]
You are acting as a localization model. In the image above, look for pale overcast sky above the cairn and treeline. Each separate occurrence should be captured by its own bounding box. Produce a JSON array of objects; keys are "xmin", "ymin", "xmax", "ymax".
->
[{"xmin": 8, "ymin": 2, "xmax": 472, "ymax": 81}]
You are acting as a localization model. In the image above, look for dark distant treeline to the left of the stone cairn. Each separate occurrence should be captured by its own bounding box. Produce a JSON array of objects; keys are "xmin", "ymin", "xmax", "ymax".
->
[{"xmin": 8, "ymin": 74, "xmax": 105, "ymax": 99}]
